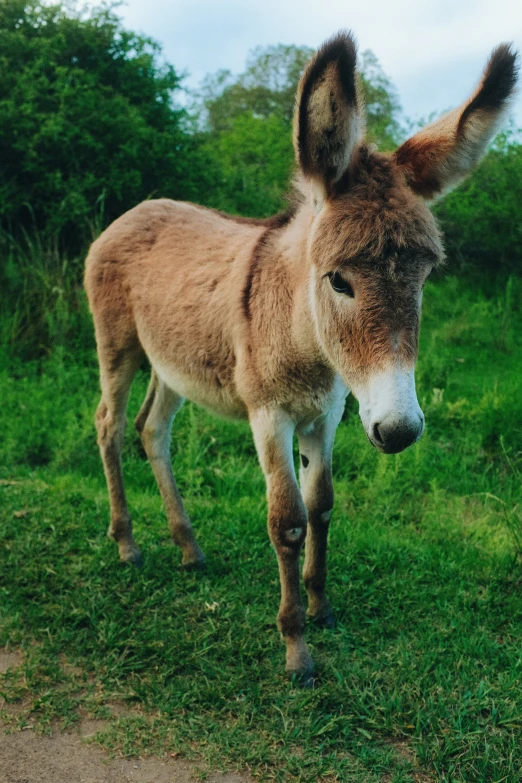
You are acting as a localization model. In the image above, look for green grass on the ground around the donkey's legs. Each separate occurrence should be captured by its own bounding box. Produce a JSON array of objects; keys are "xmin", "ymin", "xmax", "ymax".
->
[{"xmin": 0, "ymin": 278, "xmax": 522, "ymax": 783}]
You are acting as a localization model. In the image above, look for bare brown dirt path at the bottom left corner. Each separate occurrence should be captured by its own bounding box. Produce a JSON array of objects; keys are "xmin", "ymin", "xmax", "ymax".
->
[{"xmin": 0, "ymin": 652, "xmax": 252, "ymax": 783}]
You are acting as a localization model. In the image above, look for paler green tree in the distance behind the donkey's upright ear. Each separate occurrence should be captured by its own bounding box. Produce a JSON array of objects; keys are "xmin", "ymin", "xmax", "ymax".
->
[{"xmin": 198, "ymin": 44, "xmax": 401, "ymax": 217}]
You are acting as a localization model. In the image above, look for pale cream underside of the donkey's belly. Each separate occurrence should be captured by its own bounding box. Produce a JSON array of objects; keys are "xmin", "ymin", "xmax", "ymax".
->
[{"xmin": 148, "ymin": 353, "xmax": 248, "ymax": 419}]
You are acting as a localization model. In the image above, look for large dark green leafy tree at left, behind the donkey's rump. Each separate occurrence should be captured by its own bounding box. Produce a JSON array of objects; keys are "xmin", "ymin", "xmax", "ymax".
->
[{"xmin": 0, "ymin": 0, "xmax": 203, "ymax": 247}]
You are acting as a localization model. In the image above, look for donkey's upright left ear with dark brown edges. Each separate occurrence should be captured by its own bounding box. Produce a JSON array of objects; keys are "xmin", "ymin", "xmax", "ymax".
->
[{"xmin": 294, "ymin": 32, "xmax": 364, "ymax": 207}]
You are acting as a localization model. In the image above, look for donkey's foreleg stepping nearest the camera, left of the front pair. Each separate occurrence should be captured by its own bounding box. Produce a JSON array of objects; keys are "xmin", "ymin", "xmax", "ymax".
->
[{"xmin": 250, "ymin": 409, "xmax": 313, "ymax": 681}]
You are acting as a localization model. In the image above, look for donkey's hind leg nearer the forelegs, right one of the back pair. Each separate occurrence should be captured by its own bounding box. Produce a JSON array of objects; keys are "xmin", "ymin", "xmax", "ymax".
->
[{"xmin": 136, "ymin": 370, "xmax": 205, "ymax": 568}]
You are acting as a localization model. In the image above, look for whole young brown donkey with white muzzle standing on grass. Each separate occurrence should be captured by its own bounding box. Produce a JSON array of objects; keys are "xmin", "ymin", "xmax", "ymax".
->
[{"xmin": 85, "ymin": 33, "xmax": 517, "ymax": 679}]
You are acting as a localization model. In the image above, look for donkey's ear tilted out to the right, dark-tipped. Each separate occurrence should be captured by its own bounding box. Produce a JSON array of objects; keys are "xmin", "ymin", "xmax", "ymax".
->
[{"xmin": 395, "ymin": 44, "xmax": 518, "ymax": 199}]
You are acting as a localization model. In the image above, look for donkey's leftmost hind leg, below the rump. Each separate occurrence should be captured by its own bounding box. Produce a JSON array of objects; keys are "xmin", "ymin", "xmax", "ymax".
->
[{"xmin": 96, "ymin": 349, "xmax": 141, "ymax": 565}]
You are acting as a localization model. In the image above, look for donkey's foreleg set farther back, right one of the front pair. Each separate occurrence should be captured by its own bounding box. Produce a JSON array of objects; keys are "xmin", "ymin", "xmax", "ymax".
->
[{"xmin": 298, "ymin": 409, "xmax": 342, "ymax": 628}]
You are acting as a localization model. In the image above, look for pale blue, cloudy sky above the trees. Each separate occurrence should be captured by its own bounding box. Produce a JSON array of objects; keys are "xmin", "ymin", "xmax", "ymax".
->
[{"xmin": 119, "ymin": 0, "xmax": 522, "ymax": 126}]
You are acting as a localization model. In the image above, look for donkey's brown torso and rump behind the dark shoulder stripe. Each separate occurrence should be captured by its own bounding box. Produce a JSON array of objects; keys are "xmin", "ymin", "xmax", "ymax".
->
[{"xmin": 85, "ymin": 199, "xmax": 264, "ymax": 416}]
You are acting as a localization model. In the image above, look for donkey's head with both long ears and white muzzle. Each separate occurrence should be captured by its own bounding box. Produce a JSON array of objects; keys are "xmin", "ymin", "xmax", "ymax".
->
[{"xmin": 294, "ymin": 34, "xmax": 517, "ymax": 453}]
